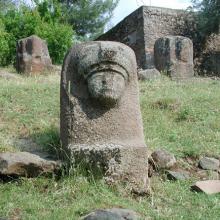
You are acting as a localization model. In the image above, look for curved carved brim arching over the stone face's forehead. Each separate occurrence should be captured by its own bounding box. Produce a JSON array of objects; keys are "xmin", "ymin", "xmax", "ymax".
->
[{"xmin": 85, "ymin": 62, "xmax": 129, "ymax": 81}]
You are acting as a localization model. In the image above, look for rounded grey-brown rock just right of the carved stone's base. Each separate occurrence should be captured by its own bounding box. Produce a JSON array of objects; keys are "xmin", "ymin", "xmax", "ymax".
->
[{"xmin": 151, "ymin": 149, "xmax": 176, "ymax": 169}]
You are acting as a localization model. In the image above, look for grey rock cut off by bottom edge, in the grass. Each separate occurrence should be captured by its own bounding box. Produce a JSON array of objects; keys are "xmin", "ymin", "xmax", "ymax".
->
[{"xmin": 83, "ymin": 208, "xmax": 139, "ymax": 220}]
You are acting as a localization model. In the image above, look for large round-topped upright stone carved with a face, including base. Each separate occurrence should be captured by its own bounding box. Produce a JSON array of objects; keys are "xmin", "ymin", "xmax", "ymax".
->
[{"xmin": 60, "ymin": 41, "xmax": 148, "ymax": 191}]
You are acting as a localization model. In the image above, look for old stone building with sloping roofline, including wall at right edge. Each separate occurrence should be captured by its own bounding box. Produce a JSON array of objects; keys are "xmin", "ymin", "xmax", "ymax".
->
[{"xmin": 97, "ymin": 6, "xmax": 220, "ymax": 75}]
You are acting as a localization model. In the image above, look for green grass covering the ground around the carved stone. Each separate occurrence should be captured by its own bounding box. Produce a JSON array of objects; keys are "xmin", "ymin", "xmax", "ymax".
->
[{"xmin": 0, "ymin": 72, "xmax": 220, "ymax": 220}]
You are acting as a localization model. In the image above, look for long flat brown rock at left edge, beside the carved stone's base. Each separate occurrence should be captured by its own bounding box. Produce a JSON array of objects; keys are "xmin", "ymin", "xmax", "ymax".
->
[{"xmin": 0, "ymin": 152, "xmax": 60, "ymax": 177}]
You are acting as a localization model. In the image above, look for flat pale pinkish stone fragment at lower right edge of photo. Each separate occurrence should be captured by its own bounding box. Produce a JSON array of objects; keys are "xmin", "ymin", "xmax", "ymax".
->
[{"xmin": 191, "ymin": 180, "xmax": 220, "ymax": 194}]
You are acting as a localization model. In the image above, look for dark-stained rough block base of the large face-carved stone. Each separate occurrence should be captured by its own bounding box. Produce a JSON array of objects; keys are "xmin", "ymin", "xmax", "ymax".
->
[{"xmin": 65, "ymin": 144, "xmax": 148, "ymax": 193}]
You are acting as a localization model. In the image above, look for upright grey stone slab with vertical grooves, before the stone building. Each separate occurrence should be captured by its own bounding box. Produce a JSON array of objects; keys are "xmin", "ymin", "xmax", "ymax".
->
[{"xmin": 154, "ymin": 36, "xmax": 194, "ymax": 79}]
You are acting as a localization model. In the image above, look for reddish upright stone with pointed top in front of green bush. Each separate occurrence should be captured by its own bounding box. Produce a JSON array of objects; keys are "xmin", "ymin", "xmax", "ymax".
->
[{"xmin": 16, "ymin": 35, "xmax": 52, "ymax": 75}]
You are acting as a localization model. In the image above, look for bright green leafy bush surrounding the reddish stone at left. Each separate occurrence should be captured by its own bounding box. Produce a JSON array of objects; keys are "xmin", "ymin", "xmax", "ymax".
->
[{"xmin": 0, "ymin": 6, "xmax": 73, "ymax": 65}]
